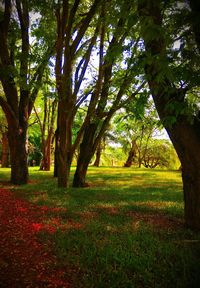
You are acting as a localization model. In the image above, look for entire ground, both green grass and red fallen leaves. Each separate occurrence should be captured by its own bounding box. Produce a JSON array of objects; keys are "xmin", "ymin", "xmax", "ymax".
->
[{"xmin": 0, "ymin": 167, "xmax": 200, "ymax": 288}]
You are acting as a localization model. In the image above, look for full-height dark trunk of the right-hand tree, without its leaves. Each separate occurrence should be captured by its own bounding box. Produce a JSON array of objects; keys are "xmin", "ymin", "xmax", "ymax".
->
[{"xmin": 138, "ymin": 0, "xmax": 200, "ymax": 230}]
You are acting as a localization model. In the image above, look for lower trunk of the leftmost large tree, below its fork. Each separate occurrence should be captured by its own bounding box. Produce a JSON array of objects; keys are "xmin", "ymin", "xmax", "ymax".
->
[{"xmin": 8, "ymin": 125, "xmax": 29, "ymax": 185}]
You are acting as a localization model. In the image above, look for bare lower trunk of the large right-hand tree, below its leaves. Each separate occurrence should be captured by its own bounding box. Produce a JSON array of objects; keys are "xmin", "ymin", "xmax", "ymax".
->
[{"xmin": 168, "ymin": 118, "xmax": 200, "ymax": 230}]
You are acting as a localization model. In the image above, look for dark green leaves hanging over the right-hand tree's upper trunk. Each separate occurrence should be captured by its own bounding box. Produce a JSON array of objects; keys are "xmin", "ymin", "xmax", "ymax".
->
[{"xmin": 140, "ymin": 1, "xmax": 200, "ymax": 128}]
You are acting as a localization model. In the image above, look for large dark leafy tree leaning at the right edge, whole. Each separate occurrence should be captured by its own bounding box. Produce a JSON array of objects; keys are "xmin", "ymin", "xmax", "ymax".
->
[{"xmin": 138, "ymin": 0, "xmax": 200, "ymax": 230}]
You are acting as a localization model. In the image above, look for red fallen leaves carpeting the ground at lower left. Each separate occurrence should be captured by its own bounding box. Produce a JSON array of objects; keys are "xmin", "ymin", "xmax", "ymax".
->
[{"xmin": 0, "ymin": 189, "xmax": 70, "ymax": 288}]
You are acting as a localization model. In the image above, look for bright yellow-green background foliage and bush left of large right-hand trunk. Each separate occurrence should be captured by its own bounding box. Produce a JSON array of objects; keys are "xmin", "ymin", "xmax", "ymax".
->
[{"xmin": 112, "ymin": 100, "xmax": 180, "ymax": 169}]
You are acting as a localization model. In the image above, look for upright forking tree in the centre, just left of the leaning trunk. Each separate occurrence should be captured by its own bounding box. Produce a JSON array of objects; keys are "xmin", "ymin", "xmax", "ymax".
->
[{"xmin": 55, "ymin": 0, "xmax": 100, "ymax": 187}]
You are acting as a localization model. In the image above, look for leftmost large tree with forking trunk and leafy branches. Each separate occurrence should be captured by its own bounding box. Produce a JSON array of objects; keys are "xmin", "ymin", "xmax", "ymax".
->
[{"xmin": 0, "ymin": 0, "xmax": 53, "ymax": 184}]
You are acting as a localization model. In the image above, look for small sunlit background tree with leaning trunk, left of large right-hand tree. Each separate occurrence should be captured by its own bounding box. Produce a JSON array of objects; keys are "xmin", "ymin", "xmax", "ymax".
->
[{"xmin": 113, "ymin": 100, "xmax": 162, "ymax": 167}]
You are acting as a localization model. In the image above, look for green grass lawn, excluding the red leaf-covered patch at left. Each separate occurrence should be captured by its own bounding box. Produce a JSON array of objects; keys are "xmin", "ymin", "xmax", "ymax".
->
[{"xmin": 0, "ymin": 167, "xmax": 200, "ymax": 288}]
